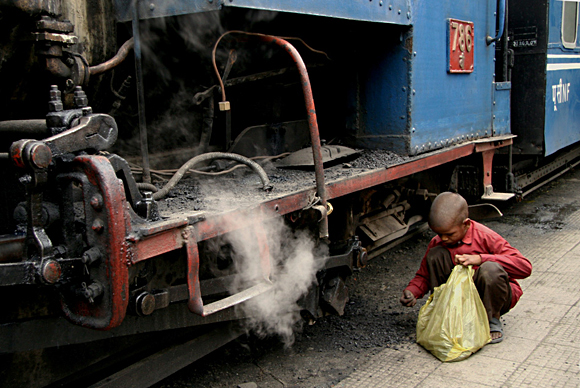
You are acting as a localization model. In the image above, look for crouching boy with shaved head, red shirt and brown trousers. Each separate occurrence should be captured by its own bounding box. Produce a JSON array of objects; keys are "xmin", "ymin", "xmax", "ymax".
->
[{"xmin": 400, "ymin": 192, "xmax": 532, "ymax": 343}]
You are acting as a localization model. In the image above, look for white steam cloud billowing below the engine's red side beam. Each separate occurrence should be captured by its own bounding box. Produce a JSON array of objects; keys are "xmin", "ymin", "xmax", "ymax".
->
[{"xmin": 224, "ymin": 212, "xmax": 327, "ymax": 346}]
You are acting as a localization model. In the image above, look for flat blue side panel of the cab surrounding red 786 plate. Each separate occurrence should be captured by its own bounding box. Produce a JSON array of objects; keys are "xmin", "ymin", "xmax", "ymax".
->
[{"xmin": 411, "ymin": 1, "xmax": 510, "ymax": 152}]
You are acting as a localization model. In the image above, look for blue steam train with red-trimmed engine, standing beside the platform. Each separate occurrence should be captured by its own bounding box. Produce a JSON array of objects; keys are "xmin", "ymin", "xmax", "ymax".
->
[{"xmin": 0, "ymin": 0, "xmax": 580, "ymax": 386}]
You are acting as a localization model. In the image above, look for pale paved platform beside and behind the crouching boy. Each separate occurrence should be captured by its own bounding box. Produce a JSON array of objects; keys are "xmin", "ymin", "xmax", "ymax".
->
[{"xmin": 335, "ymin": 203, "xmax": 580, "ymax": 388}]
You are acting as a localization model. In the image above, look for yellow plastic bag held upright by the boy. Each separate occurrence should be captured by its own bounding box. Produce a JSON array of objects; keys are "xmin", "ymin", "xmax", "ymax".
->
[{"xmin": 417, "ymin": 265, "xmax": 491, "ymax": 361}]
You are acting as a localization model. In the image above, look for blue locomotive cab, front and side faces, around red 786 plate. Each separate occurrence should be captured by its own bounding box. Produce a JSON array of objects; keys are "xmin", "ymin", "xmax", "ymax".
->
[{"xmin": 348, "ymin": 1, "xmax": 509, "ymax": 155}]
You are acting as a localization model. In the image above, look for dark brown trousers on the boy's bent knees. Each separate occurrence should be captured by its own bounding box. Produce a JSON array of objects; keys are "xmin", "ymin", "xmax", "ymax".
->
[{"xmin": 426, "ymin": 246, "xmax": 512, "ymax": 320}]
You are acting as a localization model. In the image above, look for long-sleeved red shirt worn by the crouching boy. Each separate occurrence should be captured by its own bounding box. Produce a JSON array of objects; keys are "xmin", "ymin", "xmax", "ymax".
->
[{"xmin": 406, "ymin": 220, "xmax": 532, "ymax": 308}]
